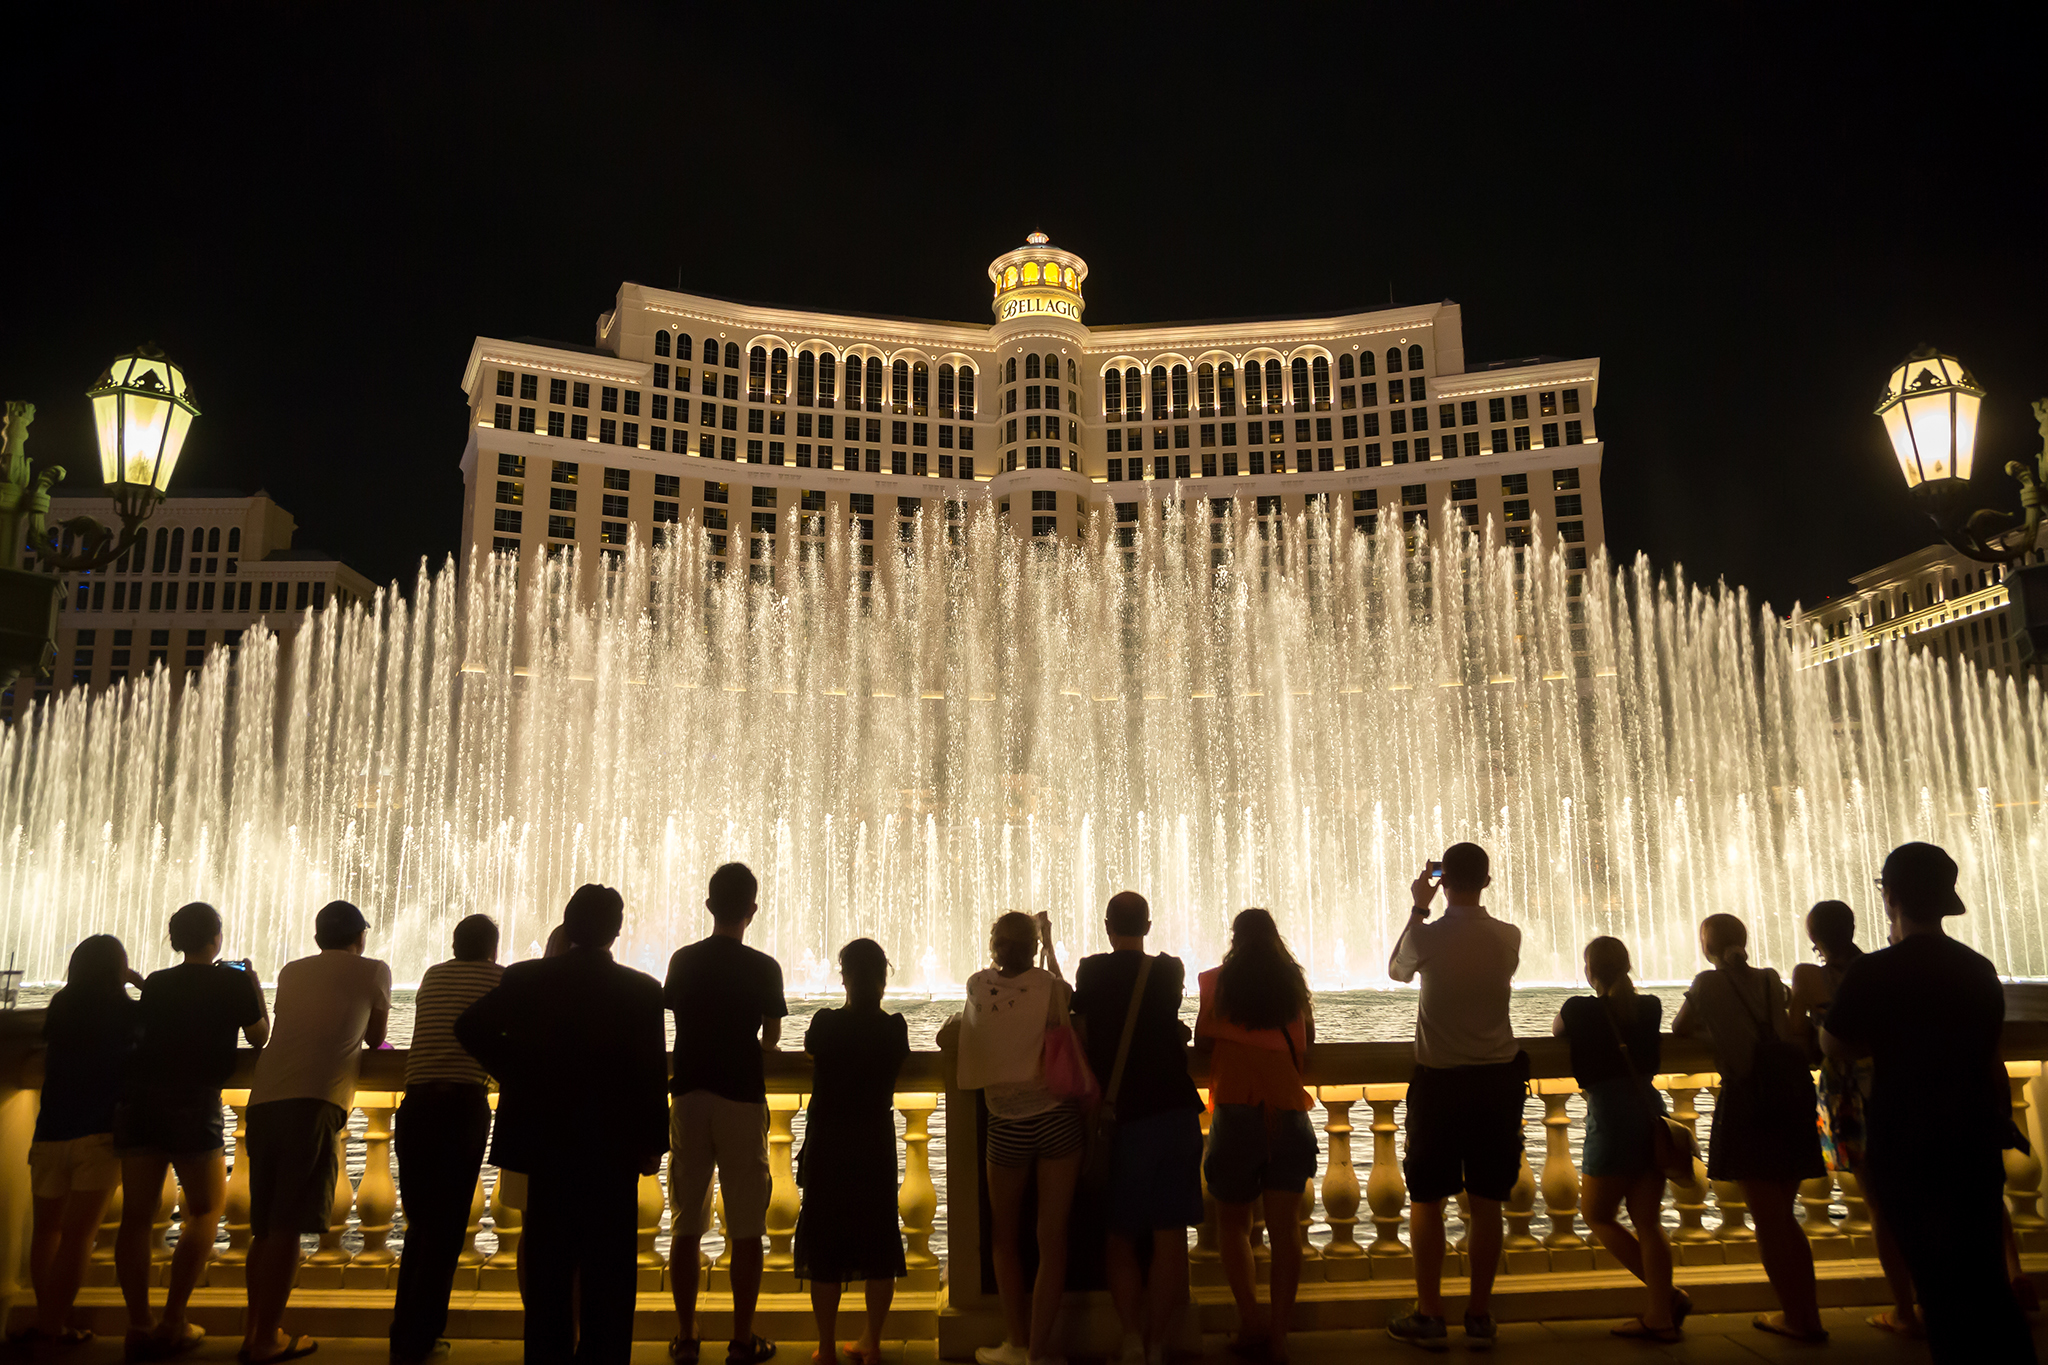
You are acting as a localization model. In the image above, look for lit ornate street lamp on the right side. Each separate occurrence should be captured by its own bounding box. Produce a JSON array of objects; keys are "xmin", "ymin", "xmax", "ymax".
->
[{"xmin": 1876, "ymin": 346, "xmax": 2048, "ymax": 661}]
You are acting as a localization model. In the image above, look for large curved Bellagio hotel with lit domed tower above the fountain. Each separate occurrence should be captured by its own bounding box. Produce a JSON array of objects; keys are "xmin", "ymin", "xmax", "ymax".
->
[{"xmin": 463, "ymin": 233, "xmax": 1604, "ymax": 587}]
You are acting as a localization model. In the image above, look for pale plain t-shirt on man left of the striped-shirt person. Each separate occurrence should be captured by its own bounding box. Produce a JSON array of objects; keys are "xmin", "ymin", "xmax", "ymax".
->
[{"xmin": 250, "ymin": 948, "xmax": 391, "ymax": 1109}]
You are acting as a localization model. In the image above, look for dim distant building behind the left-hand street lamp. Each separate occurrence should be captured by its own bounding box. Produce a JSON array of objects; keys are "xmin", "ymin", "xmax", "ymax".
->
[{"xmin": 0, "ymin": 489, "xmax": 375, "ymax": 720}]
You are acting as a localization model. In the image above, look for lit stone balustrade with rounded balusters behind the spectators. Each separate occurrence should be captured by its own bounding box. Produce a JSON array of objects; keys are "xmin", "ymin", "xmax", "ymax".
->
[{"xmin": 0, "ymin": 1013, "xmax": 2048, "ymax": 1355}]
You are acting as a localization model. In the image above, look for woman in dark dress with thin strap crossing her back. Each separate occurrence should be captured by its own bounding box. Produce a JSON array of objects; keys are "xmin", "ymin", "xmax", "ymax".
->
[{"xmin": 1671, "ymin": 915, "xmax": 1827, "ymax": 1342}]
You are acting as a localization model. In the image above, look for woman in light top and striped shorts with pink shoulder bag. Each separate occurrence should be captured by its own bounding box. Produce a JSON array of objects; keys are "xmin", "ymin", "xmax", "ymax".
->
[{"xmin": 958, "ymin": 911, "xmax": 1087, "ymax": 1365}]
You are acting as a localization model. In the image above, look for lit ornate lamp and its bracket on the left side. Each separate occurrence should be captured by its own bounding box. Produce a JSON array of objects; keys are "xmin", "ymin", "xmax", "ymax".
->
[{"xmin": 0, "ymin": 346, "xmax": 199, "ymax": 690}]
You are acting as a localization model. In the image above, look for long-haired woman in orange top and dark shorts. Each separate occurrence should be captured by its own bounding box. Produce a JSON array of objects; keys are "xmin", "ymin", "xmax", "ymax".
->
[{"xmin": 1194, "ymin": 911, "xmax": 1317, "ymax": 1361}]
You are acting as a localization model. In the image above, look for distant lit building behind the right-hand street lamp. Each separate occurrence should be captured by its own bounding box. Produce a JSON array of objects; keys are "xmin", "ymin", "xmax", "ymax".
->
[{"xmin": 1804, "ymin": 544, "xmax": 2044, "ymax": 671}]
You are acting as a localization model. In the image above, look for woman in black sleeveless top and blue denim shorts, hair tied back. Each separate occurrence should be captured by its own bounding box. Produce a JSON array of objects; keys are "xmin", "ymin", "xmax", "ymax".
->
[{"xmin": 1550, "ymin": 935, "xmax": 1692, "ymax": 1345}]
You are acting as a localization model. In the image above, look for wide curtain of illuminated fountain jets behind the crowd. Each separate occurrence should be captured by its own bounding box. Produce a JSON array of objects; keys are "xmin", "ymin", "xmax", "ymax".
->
[{"xmin": 0, "ymin": 499, "xmax": 2048, "ymax": 995}]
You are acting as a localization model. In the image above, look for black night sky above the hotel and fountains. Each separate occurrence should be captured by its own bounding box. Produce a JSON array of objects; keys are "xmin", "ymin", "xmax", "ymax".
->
[{"xmin": 0, "ymin": 4, "xmax": 2048, "ymax": 606}]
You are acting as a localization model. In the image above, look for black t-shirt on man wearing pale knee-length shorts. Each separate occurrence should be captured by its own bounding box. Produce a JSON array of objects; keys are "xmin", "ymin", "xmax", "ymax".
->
[{"xmin": 662, "ymin": 933, "xmax": 788, "ymax": 1105}]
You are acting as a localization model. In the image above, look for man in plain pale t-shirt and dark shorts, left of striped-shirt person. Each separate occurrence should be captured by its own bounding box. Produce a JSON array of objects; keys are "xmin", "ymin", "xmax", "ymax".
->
[{"xmin": 236, "ymin": 900, "xmax": 391, "ymax": 1365}]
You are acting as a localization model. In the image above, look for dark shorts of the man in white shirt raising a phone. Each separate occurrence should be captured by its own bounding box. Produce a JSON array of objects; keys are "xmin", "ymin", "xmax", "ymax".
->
[{"xmin": 1401, "ymin": 1056, "xmax": 1528, "ymax": 1203}]
